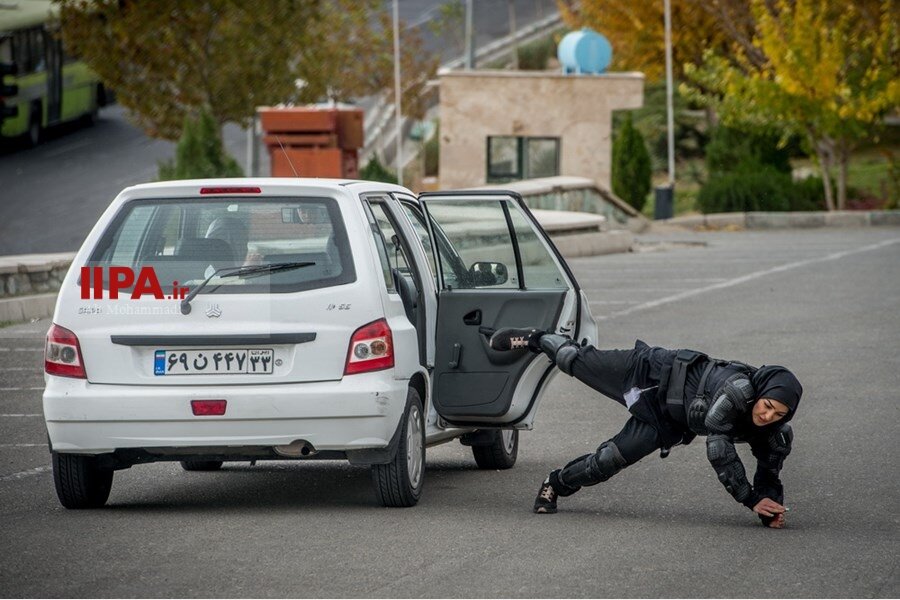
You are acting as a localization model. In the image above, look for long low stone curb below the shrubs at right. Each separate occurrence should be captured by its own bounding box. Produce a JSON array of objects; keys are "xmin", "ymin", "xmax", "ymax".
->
[{"xmin": 655, "ymin": 210, "xmax": 900, "ymax": 229}]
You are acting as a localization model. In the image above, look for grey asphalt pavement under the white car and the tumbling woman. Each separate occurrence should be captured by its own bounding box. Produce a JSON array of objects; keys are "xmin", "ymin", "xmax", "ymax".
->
[{"xmin": 0, "ymin": 228, "xmax": 900, "ymax": 598}]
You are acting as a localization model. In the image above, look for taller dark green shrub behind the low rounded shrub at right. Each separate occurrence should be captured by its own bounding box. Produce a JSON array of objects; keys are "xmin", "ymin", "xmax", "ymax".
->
[{"xmin": 706, "ymin": 126, "xmax": 791, "ymax": 174}]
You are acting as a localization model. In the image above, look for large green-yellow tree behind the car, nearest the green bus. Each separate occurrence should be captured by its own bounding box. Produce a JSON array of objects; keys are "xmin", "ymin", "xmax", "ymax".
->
[{"xmin": 57, "ymin": 0, "xmax": 321, "ymax": 139}]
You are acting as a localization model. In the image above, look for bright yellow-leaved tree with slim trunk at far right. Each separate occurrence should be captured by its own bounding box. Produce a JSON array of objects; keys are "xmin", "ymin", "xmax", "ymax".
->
[{"xmin": 686, "ymin": 0, "xmax": 900, "ymax": 210}]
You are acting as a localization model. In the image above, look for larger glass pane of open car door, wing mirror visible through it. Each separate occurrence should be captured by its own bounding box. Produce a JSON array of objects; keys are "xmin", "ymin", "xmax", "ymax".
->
[{"xmin": 428, "ymin": 200, "xmax": 520, "ymax": 289}]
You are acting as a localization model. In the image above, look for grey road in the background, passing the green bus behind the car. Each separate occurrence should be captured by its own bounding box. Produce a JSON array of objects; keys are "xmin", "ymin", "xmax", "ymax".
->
[{"xmin": 0, "ymin": 0, "xmax": 556, "ymax": 256}]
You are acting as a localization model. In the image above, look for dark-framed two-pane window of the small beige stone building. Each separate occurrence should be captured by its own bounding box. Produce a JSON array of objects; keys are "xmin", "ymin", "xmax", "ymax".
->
[{"xmin": 487, "ymin": 136, "xmax": 559, "ymax": 183}]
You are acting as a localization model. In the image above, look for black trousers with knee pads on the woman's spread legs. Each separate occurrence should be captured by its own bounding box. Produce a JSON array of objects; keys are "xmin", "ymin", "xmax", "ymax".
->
[{"xmin": 552, "ymin": 342, "xmax": 672, "ymax": 496}]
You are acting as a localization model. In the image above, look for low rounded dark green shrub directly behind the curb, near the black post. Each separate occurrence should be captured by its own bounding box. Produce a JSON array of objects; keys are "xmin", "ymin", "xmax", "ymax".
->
[{"xmin": 697, "ymin": 166, "xmax": 794, "ymax": 213}]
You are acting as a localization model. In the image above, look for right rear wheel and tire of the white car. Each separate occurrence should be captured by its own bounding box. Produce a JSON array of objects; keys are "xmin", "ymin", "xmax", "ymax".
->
[{"xmin": 372, "ymin": 388, "xmax": 425, "ymax": 507}]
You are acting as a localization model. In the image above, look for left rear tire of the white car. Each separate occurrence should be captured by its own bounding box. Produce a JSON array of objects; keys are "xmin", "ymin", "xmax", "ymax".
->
[{"xmin": 53, "ymin": 452, "xmax": 113, "ymax": 509}]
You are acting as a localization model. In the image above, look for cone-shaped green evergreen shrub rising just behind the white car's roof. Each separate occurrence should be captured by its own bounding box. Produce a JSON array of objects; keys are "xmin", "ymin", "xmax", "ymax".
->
[{"xmin": 159, "ymin": 110, "xmax": 244, "ymax": 181}]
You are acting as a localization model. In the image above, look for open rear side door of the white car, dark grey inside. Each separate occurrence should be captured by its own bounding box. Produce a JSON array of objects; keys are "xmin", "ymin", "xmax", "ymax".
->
[{"xmin": 419, "ymin": 191, "xmax": 596, "ymax": 429}]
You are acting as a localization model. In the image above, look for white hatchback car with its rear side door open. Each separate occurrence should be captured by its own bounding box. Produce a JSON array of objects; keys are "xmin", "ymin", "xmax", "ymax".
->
[{"xmin": 44, "ymin": 179, "xmax": 596, "ymax": 508}]
